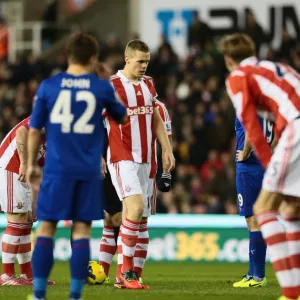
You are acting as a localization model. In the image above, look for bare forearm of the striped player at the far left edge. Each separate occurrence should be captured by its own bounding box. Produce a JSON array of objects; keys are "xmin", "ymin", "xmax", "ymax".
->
[{"xmin": 16, "ymin": 126, "xmax": 28, "ymax": 182}]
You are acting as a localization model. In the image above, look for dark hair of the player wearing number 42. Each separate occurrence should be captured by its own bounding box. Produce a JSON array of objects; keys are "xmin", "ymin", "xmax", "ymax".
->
[{"xmin": 66, "ymin": 33, "xmax": 99, "ymax": 65}]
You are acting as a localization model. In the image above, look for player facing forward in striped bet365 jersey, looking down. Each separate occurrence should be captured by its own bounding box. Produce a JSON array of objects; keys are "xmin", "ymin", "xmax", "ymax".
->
[{"xmin": 105, "ymin": 40, "xmax": 175, "ymax": 289}]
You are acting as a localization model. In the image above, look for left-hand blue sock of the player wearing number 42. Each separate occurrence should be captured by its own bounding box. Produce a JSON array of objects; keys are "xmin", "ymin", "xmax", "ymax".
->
[{"xmin": 32, "ymin": 237, "xmax": 53, "ymax": 299}]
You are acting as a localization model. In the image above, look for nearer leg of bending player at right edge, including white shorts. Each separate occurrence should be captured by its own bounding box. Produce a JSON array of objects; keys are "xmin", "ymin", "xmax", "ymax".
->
[{"xmin": 254, "ymin": 119, "xmax": 300, "ymax": 299}]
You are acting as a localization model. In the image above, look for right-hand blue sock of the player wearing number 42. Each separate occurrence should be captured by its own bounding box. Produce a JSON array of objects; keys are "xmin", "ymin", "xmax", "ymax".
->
[{"xmin": 70, "ymin": 239, "xmax": 90, "ymax": 300}]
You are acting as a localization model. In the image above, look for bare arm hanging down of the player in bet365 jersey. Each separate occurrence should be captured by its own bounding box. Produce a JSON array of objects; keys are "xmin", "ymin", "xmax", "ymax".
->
[{"xmin": 154, "ymin": 109, "xmax": 175, "ymax": 172}]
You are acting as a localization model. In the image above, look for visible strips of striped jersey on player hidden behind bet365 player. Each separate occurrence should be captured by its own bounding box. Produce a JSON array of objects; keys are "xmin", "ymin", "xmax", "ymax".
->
[{"xmin": 149, "ymin": 100, "xmax": 172, "ymax": 178}]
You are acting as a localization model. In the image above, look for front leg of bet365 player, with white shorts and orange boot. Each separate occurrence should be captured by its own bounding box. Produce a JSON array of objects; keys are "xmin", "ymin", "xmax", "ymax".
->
[{"xmin": 108, "ymin": 161, "xmax": 144, "ymax": 289}]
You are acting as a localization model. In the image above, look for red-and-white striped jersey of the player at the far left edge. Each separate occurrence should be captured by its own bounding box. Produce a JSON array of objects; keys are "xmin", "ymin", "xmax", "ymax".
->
[{"xmin": 0, "ymin": 117, "xmax": 46, "ymax": 174}]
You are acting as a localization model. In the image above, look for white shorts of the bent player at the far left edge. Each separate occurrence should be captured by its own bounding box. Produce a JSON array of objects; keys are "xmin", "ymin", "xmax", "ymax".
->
[{"xmin": 0, "ymin": 168, "xmax": 31, "ymax": 213}]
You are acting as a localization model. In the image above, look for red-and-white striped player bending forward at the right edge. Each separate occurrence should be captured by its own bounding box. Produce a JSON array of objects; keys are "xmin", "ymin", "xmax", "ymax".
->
[{"xmin": 220, "ymin": 34, "xmax": 300, "ymax": 300}]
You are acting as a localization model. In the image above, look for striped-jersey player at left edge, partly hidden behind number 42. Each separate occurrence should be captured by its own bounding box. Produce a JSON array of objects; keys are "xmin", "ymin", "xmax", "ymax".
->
[{"xmin": 0, "ymin": 118, "xmax": 45, "ymax": 285}]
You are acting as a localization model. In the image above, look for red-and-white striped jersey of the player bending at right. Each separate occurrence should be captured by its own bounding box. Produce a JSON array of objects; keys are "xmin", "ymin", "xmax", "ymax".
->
[{"xmin": 226, "ymin": 57, "xmax": 300, "ymax": 167}]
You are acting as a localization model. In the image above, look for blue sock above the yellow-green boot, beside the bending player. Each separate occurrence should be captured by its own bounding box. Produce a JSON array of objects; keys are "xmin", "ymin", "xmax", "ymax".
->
[{"xmin": 249, "ymin": 231, "xmax": 267, "ymax": 281}]
